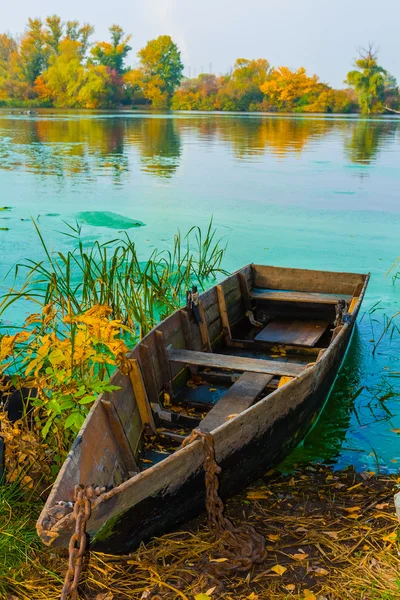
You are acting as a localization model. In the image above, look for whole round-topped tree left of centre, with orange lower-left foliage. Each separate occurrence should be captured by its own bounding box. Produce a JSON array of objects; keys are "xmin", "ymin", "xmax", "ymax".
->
[{"xmin": 133, "ymin": 35, "xmax": 183, "ymax": 107}]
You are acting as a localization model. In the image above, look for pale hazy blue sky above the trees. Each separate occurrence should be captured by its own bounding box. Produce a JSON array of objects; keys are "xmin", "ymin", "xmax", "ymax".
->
[{"xmin": 0, "ymin": 0, "xmax": 400, "ymax": 87}]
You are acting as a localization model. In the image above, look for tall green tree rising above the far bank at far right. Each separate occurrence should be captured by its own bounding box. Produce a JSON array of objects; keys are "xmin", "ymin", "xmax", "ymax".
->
[{"xmin": 345, "ymin": 44, "xmax": 396, "ymax": 114}]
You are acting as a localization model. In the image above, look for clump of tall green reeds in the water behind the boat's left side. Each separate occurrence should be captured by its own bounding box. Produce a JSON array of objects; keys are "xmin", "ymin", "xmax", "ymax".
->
[{"xmin": 0, "ymin": 219, "xmax": 226, "ymax": 337}]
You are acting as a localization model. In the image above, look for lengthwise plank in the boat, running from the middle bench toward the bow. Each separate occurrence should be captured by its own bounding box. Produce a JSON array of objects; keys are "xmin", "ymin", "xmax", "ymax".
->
[{"xmin": 198, "ymin": 372, "xmax": 273, "ymax": 432}]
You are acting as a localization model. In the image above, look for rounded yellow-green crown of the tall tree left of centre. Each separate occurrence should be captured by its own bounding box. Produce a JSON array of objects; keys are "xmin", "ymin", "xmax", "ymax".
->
[{"xmin": 138, "ymin": 35, "xmax": 183, "ymax": 99}]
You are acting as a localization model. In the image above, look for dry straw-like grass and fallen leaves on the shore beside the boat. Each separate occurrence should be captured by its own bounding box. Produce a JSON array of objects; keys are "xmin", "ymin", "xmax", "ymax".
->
[{"xmin": 4, "ymin": 467, "xmax": 400, "ymax": 600}]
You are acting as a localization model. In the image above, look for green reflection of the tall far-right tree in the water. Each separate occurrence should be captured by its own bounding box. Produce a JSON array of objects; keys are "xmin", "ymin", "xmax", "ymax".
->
[{"xmin": 344, "ymin": 119, "xmax": 399, "ymax": 164}]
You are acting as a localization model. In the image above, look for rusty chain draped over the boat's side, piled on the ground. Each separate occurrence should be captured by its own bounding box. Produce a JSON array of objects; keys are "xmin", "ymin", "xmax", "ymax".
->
[{"xmin": 182, "ymin": 429, "xmax": 265, "ymax": 578}]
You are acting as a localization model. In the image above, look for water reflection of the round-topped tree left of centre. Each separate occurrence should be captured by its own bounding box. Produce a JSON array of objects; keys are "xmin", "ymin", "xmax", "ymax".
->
[{"xmin": 128, "ymin": 117, "xmax": 181, "ymax": 177}]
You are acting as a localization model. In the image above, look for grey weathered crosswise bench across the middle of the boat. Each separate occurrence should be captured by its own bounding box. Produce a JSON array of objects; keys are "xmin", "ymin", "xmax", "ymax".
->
[{"xmin": 168, "ymin": 348, "xmax": 304, "ymax": 377}]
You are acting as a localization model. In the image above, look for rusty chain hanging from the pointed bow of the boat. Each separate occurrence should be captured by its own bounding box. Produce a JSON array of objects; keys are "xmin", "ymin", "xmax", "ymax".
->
[{"xmin": 60, "ymin": 485, "xmax": 91, "ymax": 600}]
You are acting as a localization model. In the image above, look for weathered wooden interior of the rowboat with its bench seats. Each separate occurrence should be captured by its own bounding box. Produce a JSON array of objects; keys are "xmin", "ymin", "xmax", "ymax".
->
[{"xmin": 119, "ymin": 265, "xmax": 366, "ymax": 476}]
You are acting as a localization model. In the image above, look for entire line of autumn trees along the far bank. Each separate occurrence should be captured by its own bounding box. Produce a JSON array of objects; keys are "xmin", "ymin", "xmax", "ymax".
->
[{"xmin": 0, "ymin": 15, "xmax": 400, "ymax": 114}]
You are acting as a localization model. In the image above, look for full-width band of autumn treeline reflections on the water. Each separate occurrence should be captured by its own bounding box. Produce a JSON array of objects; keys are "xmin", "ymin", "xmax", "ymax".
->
[{"xmin": 0, "ymin": 112, "xmax": 400, "ymax": 183}]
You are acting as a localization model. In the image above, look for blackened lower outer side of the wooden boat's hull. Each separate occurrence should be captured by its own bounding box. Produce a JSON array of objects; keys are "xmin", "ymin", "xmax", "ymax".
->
[{"xmin": 90, "ymin": 323, "xmax": 353, "ymax": 554}]
